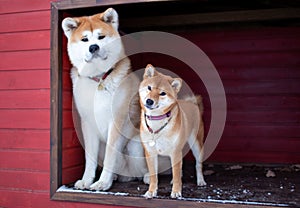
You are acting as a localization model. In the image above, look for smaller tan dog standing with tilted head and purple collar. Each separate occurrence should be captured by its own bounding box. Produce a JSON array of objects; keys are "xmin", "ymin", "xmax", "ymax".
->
[{"xmin": 139, "ymin": 64, "xmax": 206, "ymax": 199}]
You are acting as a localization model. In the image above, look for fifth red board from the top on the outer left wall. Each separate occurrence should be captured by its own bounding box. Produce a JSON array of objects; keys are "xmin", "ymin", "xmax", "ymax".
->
[{"xmin": 0, "ymin": 69, "xmax": 50, "ymax": 90}]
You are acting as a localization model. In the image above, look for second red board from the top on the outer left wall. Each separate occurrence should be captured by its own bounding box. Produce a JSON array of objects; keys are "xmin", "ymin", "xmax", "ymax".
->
[{"xmin": 0, "ymin": 10, "xmax": 50, "ymax": 33}]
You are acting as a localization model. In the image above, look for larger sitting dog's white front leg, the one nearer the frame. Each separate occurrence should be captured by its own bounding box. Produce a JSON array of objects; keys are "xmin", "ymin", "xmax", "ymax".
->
[{"xmin": 75, "ymin": 122, "xmax": 100, "ymax": 189}]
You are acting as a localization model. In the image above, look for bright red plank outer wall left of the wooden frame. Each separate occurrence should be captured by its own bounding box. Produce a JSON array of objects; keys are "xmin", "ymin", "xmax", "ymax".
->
[{"xmin": 0, "ymin": 0, "xmax": 123, "ymax": 208}]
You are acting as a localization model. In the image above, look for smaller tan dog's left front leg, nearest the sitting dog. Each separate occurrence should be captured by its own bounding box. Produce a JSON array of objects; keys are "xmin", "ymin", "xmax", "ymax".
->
[{"xmin": 144, "ymin": 150, "xmax": 158, "ymax": 199}]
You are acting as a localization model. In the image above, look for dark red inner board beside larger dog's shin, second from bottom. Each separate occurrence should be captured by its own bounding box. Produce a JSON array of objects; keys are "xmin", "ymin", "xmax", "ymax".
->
[{"xmin": 62, "ymin": 147, "xmax": 85, "ymax": 168}]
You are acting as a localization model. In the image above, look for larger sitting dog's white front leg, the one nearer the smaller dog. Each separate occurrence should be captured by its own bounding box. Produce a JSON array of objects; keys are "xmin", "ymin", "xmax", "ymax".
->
[{"xmin": 90, "ymin": 125, "xmax": 126, "ymax": 191}]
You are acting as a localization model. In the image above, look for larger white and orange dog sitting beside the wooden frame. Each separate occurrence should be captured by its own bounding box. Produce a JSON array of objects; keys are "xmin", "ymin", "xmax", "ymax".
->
[{"xmin": 62, "ymin": 8, "xmax": 148, "ymax": 190}]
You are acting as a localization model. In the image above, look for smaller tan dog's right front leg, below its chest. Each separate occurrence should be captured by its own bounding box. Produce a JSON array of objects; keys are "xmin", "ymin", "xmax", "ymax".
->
[{"xmin": 171, "ymin": 151, "xmax": 182, "ymax": 198}]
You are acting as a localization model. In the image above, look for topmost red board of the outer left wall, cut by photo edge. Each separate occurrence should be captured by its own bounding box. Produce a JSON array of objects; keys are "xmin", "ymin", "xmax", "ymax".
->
[{"xmin": 0, "ymin": 0, "xmax": 51, "ymax": 14}]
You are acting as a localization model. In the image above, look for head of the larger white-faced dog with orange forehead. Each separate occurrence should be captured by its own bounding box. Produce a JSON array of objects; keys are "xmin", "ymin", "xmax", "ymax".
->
[{"xmin": 62, "ymin": 8, "xmax": 124, "ymax": 74}]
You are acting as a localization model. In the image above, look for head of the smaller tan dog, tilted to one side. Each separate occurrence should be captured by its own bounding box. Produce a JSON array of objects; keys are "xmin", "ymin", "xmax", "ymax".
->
[{"xmin": 139, "ymin": 64, "xmax": 182, "ymax": 114}]
